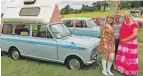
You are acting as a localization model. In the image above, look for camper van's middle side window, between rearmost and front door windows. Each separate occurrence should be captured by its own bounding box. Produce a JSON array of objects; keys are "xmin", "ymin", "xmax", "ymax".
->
[{"xmin": 14, "ymin": 24, "xmax": 30, "ymax": 36}]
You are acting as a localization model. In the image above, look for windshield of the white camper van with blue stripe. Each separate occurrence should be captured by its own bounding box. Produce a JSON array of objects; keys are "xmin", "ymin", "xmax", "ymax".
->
[{"xmin": 50, "ymin": 24, "xmax": 71, "ymax": 39}]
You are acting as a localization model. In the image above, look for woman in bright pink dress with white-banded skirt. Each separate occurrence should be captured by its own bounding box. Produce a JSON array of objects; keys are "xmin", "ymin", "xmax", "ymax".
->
[{"xmin": 115, "ymin": 12, "xmax": 138, "ymax": 76}]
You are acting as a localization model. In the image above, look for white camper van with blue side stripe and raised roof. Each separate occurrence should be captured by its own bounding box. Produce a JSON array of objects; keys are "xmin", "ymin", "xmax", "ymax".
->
[{"xmin": 0, "ymin": 0, "xmax": 99, "ymax": 69}]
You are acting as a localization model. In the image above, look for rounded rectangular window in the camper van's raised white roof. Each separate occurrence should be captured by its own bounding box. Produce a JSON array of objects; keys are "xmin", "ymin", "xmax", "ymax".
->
[{"xmin": 19, "ymin": 7, "xmax": 40, "ymax": 16}]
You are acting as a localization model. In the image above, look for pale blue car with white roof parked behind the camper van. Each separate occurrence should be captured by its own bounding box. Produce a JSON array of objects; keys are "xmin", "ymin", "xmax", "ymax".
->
[{"xmin": 62, "ymin": 18, "xmax": 100, "ymax": 38}]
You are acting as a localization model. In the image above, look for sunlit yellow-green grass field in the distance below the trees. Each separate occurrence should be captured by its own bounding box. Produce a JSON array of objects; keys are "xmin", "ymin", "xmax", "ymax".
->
[{"xmin": 63, "ymin": 10, "xmax": 127, "ymax": 18}]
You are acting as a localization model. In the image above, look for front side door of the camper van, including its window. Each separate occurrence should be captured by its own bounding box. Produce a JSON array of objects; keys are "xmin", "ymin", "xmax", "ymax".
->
[{"xmin": 29, "ymin": 25, "xmax": 57, "ymax": 60}]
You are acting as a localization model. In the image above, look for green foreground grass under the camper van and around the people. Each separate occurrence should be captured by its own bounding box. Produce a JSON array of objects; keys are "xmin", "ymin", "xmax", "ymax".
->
[{"xmin": 1, "ymin": 28, "xmax": 143, "ymax": 76}]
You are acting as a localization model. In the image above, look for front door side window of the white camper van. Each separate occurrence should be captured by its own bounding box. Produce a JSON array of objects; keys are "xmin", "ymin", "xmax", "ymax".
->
[{"xmin": 32, "ymin": 25, "xmax": 52, "ymax": 38}]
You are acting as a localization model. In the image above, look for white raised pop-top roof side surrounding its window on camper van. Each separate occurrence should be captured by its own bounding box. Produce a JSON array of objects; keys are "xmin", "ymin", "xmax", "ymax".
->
[{"xmin": 2, "ymin": 0, "xmax": 57, "ymax": 24}]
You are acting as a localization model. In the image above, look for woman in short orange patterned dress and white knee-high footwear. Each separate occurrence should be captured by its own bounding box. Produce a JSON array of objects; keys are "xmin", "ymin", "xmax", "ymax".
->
[{"xmin": 99, "ymin": 15, "xmax": 115, "ymax": 75}]
